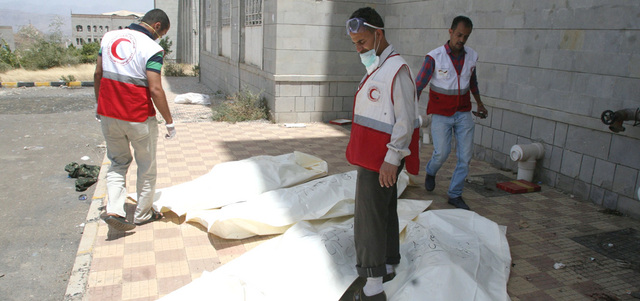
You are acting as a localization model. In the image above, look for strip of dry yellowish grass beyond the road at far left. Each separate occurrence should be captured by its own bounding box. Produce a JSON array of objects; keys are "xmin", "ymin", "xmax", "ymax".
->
[{"xmin": 0, "ymin": 64, "xmax": 96, "ymax": 82}]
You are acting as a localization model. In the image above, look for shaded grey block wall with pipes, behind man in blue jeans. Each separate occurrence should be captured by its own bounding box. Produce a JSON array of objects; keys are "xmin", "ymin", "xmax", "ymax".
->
[{"xmin": 385, "ymin": 0, "xmax": 640, "ymax": 217}]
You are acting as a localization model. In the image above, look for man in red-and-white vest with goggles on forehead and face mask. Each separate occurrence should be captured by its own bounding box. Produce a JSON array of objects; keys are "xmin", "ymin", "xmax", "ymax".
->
[{"xmin": 346, "ymin": 7, "xmax": 420, "ymax": 301}]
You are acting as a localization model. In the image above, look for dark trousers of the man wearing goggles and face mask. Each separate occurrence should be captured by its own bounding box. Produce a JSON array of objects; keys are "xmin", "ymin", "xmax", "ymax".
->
[{"xmin": 354, "ymin": 160, "xmax": 404, "ymax": 277}]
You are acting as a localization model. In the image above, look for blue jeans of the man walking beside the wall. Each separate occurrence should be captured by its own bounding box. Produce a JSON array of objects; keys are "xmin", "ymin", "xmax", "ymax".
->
[{"xmin": 426, "ymin": 112, "xmax": 475, "ymax": 198}]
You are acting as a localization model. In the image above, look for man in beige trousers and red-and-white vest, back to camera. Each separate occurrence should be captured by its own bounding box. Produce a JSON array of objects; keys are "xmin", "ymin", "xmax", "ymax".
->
[{"xmin": 94, "ymin": 9, "xmax": 176, "ymax": 231}]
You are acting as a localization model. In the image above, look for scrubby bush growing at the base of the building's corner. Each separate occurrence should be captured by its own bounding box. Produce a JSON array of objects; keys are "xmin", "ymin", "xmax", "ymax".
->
[{"xmin": 212, "ymin": 89, "xmax": 269, "ymax": 123}]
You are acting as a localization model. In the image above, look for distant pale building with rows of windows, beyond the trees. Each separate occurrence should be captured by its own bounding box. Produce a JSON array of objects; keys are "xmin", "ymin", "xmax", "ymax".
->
[{"xmin": 71, "ymin": 11, "xmax": 144, "ymax": 47}]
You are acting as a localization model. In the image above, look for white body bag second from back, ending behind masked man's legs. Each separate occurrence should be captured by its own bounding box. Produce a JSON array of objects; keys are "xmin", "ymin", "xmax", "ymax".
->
[{"xmin": 186, "ymin": 170, "xmax": 409, "ymax": 239}]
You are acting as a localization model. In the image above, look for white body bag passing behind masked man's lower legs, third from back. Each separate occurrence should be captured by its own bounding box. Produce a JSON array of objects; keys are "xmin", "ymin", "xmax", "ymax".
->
[{"xmin": 160, "ymin": 199, "xmax": 431, "ymax": 301}]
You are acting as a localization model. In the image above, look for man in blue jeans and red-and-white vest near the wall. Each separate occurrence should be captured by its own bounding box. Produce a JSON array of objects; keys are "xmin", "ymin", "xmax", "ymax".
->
[{"xmin": 416, "ymin": 16, "xmax": 488, "ymax": 210}]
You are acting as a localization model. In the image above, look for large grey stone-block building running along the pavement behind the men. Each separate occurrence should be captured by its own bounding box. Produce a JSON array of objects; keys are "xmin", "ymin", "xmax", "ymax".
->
[{"xmin": 199, "ymin": 0, "xmax": 640, "ymax": 218}]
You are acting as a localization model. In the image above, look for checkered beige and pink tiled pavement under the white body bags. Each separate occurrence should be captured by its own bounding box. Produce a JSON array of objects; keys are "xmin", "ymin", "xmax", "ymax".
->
[{"xmin": 65, "ymin": 78, "xmax": 640, "ymax": 301}]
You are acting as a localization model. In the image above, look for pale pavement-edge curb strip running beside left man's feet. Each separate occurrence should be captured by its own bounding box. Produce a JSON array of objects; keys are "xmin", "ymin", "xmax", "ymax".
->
[{"xmin": 64, "ymin": 154, "xmax": 111, "ymax": 301}]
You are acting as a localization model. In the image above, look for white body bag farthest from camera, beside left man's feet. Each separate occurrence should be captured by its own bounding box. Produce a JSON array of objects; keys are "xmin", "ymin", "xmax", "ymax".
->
[{"xmin": 141, "ymin": 151, "xmax": 329, "ymax": 215}]
